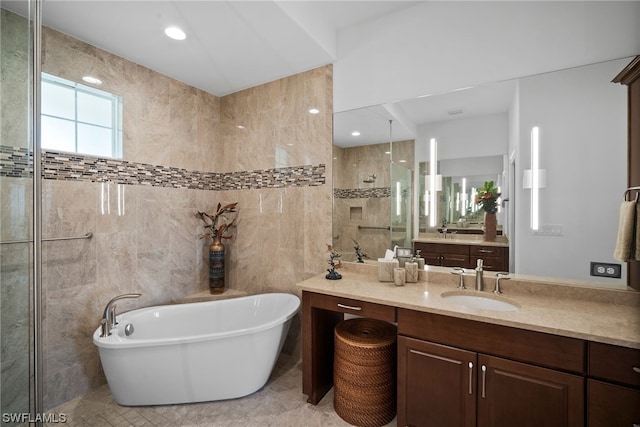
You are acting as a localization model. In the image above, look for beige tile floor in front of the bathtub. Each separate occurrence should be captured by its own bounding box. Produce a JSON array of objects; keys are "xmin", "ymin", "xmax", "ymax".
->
[{"xmin": 47, "ymin": 354, "xmax": 396, "ymax": 427}]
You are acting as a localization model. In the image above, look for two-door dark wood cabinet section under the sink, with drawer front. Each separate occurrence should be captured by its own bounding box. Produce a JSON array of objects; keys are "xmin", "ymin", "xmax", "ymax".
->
[{"xmin": 398, "ymin": 309, "xmax": 585, "ymax": 427}]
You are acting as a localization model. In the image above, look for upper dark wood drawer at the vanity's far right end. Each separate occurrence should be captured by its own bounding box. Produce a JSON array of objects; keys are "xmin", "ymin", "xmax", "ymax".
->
[{"xmin": 589, "ymin": 342, "xmax": 640, "ymax": 387}]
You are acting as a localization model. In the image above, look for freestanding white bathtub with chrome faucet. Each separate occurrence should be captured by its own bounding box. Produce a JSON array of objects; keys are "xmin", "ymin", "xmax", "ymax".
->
[{"xmin": 93, "ymin": 293, "xmax": 300, "ymax": 406}]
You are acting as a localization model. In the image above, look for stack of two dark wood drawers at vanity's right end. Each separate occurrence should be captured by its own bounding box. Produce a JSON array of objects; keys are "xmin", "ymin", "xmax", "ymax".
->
[{"xmin": 587, "ymin": 342, "xmax": 640, "ymax": 427}]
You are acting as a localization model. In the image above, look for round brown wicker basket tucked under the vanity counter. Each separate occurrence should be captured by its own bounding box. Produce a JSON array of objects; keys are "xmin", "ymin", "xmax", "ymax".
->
[{"xmin": 333, "ymin": 318, "xmax": 397, "ymax": 427}]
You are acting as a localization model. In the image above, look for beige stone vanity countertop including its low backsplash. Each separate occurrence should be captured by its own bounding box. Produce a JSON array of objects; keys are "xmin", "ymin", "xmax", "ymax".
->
[{"xmin": 298, "ymin": 264, "xmax": 640, "ymax": 349}]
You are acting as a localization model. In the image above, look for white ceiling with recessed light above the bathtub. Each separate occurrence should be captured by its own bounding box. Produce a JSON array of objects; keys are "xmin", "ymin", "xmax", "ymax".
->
[{"xmin": 2, "ymin": 0, "xmax": 419, "ymax": 96}]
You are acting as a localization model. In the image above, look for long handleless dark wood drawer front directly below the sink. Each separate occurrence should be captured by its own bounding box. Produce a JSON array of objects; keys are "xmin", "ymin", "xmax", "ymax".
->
[{"xmin": 398, "ymin": 308, "xmax": 586, "ymax": 374}]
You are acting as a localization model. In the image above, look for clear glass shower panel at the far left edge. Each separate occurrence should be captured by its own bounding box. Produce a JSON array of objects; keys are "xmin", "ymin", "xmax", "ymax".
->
[{"xmin": 0, "ymin": 2, "xmax": 33, "ymax": 425}]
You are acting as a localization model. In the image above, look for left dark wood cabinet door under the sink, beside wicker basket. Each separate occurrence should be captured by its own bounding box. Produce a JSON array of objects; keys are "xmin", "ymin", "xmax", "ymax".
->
[{"xmin": 398, "ymin": 336, "xmax": 477, "ymax": 427}]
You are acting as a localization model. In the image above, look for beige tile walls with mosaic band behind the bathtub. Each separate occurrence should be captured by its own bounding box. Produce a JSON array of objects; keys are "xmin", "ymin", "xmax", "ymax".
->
[{"xmin": 2, "ymin": 10, "xmax": 332, "ymax": 408}]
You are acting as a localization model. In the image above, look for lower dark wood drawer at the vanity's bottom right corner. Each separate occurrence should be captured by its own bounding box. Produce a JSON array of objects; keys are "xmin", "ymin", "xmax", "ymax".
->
[{"xmin": 587, "ymin": 380, "xmax": 640, "ymax": 427}]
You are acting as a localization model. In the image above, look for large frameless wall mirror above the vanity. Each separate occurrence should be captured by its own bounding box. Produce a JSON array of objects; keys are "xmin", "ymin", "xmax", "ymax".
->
[{"xmin": 334, "ymin": 58, "xmax": 632, "ymax": 288}]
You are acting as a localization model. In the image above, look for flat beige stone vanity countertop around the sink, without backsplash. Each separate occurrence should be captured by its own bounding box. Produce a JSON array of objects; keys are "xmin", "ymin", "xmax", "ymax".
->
[{"xmin": 297, "ymin": 271, "xmax": 640, "ymax": 349}]
